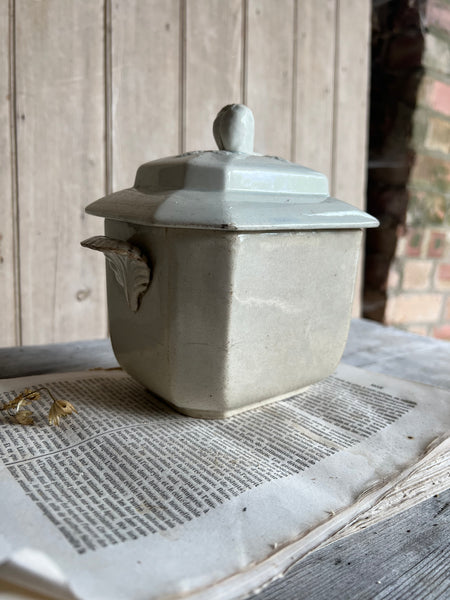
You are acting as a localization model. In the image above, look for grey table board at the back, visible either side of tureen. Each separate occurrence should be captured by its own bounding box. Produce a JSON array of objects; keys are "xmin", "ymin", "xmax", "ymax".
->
[{"xmin": 0, "ymin": 319, "xmax": 450, "ymax": 390}]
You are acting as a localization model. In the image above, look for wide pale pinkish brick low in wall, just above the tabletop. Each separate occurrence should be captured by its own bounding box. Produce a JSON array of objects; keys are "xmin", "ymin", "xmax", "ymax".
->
[{"xmin": 386, "ymin": 294, "xmax": 443, "ymax": 325}]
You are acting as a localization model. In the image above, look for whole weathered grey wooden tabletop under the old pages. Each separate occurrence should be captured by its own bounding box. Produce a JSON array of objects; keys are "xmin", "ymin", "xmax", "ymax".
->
[{"xmin": 0, "ymin": 319, "xmax": 450, "ymax": 600}]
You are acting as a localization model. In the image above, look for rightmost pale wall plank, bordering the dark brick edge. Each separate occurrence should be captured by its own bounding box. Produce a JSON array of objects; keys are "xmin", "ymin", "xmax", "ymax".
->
[{"xmin": 331, "ymin": 0, "xmax": 371, "ymax": 316}]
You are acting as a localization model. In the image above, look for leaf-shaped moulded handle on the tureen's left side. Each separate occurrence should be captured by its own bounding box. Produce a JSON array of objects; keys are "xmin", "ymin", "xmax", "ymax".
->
[{"xmin": 81, "ymin": 235, "xmax": 152, "ymax": 312}]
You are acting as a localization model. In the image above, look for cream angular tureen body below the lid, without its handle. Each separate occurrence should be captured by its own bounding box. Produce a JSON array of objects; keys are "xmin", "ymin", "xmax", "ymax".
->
[{"xmin": 106, "ymin": 220, "xmax": 361, "ymax": 418}]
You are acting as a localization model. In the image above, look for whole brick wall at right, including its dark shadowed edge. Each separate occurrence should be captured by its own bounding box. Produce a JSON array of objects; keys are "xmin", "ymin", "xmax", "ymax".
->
[{"xmin": 364, "ymin": 0, "xmax": 450, "ymax": 340}]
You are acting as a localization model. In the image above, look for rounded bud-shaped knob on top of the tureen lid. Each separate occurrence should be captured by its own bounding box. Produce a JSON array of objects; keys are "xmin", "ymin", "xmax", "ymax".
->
[{"xmin": 213, "ymin": 104, "xmax": 255, "ymax": 154}]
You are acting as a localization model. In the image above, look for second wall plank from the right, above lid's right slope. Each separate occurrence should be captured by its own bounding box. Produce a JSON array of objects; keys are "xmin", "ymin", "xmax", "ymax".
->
[{"xmin": 293, "ymin": 0, "xmax": 336, "ymax": 178}]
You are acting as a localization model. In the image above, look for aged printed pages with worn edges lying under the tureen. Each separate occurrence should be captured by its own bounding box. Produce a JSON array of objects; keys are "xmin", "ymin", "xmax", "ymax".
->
[{"xmin": 0, "ymin": 364, "xmax": 450, "ymax": 600}]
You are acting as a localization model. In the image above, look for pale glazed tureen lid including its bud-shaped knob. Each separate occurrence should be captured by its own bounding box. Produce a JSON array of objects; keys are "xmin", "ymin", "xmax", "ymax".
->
[{"xmin": 86, "ymin": 104, "xmax": 378, "ymax": 231}]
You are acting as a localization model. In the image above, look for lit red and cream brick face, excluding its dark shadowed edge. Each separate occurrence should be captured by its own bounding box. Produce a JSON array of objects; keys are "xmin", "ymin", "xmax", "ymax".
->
[{"xmin": 385, "ymin": 0, "xmax": 450, "ymax": 340}]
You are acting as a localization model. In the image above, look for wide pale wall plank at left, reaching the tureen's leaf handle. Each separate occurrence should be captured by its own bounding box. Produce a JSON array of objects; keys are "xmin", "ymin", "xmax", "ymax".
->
[{"xmin": 16, "ymin": 0, "xmax": 106, "ymax": 344}]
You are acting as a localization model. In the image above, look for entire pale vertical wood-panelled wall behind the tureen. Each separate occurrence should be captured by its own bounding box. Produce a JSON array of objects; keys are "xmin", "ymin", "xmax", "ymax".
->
[{"xmin": 0, "ymin": 0, "xmax": 370, "ymax": 346}]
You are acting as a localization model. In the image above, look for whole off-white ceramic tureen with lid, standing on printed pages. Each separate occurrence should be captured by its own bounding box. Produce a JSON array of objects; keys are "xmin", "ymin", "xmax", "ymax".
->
[{"xmin": 82, "ymin": 105, "xmax": 378, "ymax": 418}]
